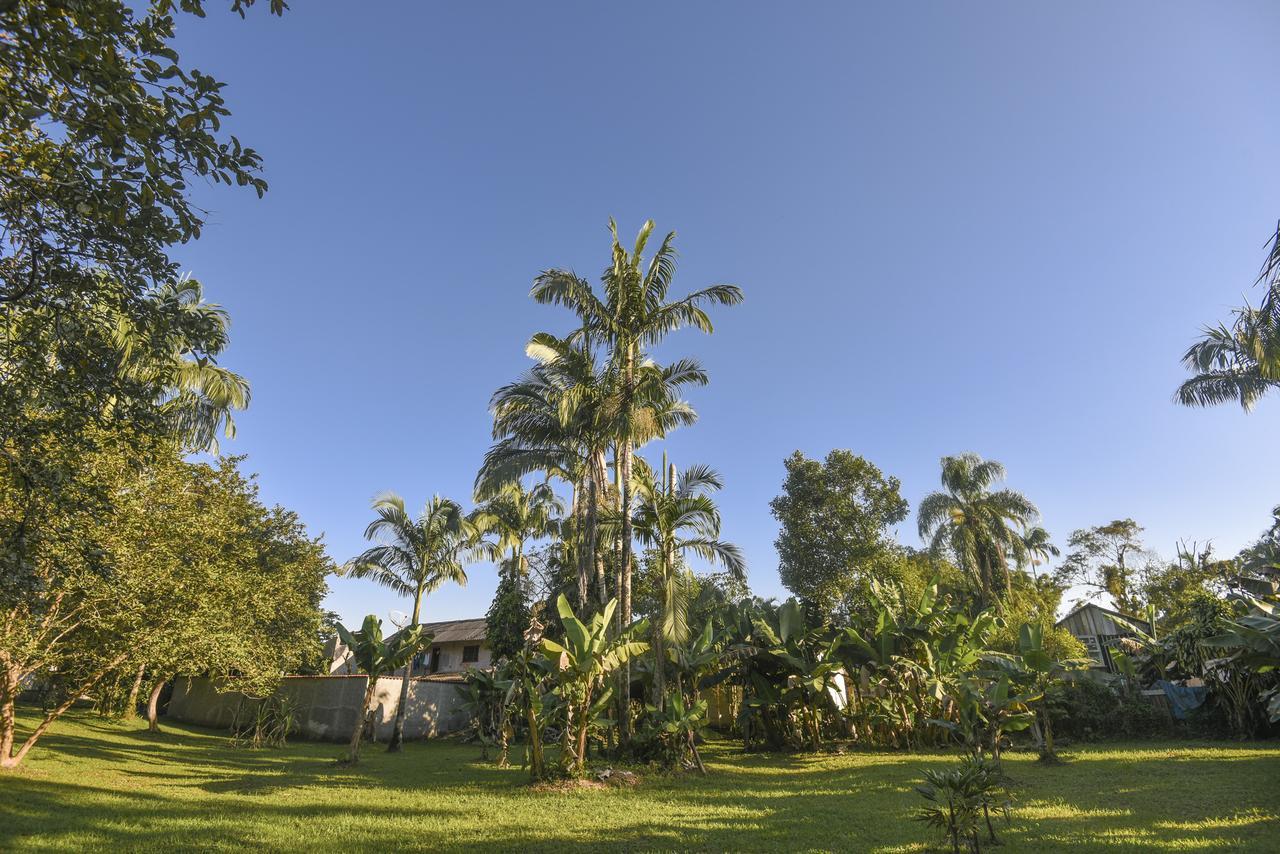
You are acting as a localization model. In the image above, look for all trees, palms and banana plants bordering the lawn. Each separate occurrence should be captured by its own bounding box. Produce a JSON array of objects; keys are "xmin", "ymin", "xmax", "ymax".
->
[{"xmin": 0, "ymin": 0, "xmax": 1280, "ymax": 851}]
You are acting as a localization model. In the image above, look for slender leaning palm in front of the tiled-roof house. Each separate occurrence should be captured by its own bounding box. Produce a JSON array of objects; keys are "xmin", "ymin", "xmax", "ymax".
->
[{"xmin": 342, "ymin": 492, "xmax": 477, "ymax": 750}]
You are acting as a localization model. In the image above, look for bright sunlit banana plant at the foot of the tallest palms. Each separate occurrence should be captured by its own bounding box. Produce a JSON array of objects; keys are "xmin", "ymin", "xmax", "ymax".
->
[{"xmin": 541, "ymin": 593, "xmax": 649, "ymax": 776}]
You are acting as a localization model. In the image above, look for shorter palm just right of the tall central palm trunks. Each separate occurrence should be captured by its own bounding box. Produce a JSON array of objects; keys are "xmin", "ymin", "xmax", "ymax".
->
[{"xmin": 632, "ymin": 455, "xmax": 746, "ymax": 709}]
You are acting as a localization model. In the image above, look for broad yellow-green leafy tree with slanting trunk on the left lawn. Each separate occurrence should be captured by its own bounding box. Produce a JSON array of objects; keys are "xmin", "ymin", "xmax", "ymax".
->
[{"xmin": 0, "ymin": 445, "xmax": 332, "ymax": 766}]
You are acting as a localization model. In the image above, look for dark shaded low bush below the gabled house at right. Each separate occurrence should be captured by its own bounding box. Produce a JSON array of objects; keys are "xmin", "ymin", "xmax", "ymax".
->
[{"xmin": 1046, "ymin": 679, "xmax": 1169, "ymax": 741}]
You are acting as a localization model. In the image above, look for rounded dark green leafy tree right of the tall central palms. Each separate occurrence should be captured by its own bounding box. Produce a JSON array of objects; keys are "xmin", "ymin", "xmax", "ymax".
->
[{"xmin": 769, "ymin": 449, "xmax": 908, "ymax": 613}]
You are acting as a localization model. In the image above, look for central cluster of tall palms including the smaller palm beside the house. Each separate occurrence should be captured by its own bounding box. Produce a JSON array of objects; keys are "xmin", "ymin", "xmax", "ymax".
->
[{"xmin": 335, "ymin": 220, "xmax": 745, "ymax": 768}]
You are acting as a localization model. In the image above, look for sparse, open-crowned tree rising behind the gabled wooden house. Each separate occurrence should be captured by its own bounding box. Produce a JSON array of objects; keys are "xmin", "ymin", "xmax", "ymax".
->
[{"xmin": 1056, "ymin": 519, "xmax": 1149, "ymax": 613}]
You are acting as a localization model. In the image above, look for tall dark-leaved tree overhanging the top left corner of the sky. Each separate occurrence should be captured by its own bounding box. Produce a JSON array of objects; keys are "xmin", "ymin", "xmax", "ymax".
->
[{"xmin": 0, "ymin": 0, "xmax": 276, "ymax": 607}]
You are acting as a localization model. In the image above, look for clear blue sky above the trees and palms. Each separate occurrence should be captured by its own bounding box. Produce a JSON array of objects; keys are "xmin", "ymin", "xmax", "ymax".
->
[{"xmin": 172, "ymin": 1, "xmax": 1280, "ymax": 621}]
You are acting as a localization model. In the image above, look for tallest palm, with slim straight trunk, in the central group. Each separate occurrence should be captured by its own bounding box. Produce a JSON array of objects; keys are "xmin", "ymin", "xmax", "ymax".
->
[{"xmin": 531, "ymin": 219, "xmax": 742, "ymax": 737}]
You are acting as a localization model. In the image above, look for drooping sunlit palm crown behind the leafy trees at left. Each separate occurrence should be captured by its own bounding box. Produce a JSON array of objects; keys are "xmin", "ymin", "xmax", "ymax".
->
[{"xmin": 115, "ymin": 277, "xmax": 250, "ymax": 453}]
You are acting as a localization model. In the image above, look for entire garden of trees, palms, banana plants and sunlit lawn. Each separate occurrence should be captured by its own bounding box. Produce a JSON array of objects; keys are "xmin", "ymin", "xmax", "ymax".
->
[{"xmin": 0, "ymin": 0, "xmax": 1280, "ymax": 854}]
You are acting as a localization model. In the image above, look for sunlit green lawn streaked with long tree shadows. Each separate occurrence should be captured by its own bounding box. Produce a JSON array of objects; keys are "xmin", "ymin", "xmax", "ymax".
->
[{"xmin": 0, "ymin": 714, "xmax": 1280, "ymax": 853}]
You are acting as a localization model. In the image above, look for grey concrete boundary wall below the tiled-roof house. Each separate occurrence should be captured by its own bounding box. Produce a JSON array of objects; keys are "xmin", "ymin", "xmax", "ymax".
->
[{"xmin": 169, "ymin": 673, "xmax": 471, "ymax": 741}]
